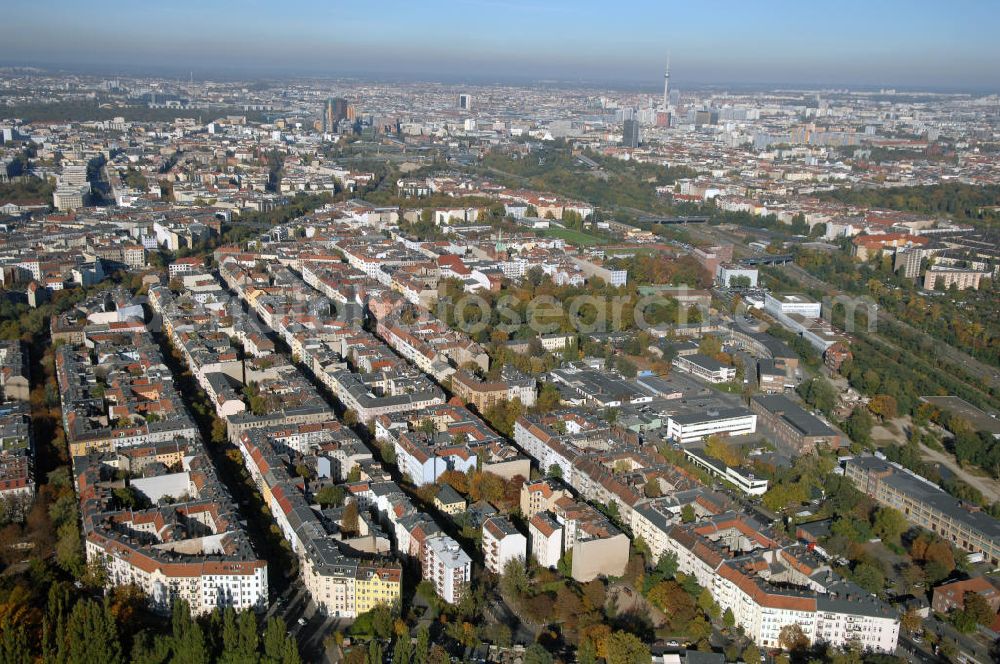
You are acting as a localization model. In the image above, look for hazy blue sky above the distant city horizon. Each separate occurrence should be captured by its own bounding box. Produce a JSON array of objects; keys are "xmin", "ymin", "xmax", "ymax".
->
[{"xmin": 0, "ymin": 0, "xmax": 1000, "ymax": 91}]
